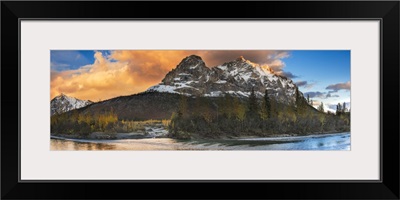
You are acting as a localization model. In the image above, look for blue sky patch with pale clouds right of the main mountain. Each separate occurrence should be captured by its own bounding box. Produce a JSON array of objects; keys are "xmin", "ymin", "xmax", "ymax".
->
[{"xmin": 283, "ymin": 50, "xmax": 350, "ymax": 111}]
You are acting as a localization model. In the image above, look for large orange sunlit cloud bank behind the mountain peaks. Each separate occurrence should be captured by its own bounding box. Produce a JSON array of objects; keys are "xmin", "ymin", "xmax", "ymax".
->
[{"xmin": 50, "ymin": 50, "xmax": 288, "ymax": 101}]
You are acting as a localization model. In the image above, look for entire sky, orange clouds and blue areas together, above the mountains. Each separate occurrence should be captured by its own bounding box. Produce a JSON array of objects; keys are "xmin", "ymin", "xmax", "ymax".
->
[{"xmin": 50, "ymin": 50, "xmax": 351, "ymax": 111}]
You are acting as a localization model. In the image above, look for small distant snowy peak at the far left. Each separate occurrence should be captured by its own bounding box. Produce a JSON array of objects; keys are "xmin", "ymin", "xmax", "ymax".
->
[{"xmin": 50, "ymin": 94, "xmax": 93, "ymax": 115}]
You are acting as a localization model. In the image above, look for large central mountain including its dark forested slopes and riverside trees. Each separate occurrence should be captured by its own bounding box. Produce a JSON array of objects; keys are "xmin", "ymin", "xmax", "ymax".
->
[{"xmin": 52, "ymin": 55, "xmax": 350, "ymax": 138}]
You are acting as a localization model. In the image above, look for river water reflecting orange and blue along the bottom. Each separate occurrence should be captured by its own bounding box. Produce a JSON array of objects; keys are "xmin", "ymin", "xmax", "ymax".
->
[{"xmin": 50, "ymin": 132, "xmax": 351, "ymax": 151}]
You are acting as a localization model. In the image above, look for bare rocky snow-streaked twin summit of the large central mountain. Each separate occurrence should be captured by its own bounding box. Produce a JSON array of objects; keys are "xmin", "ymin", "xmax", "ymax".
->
[{"xmin": 147, "ymin": 55, "xmax": 303, "ymax": 103}]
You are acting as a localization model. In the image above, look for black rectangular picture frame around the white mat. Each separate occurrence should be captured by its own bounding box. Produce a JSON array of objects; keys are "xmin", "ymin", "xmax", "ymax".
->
[{"xmin": 1, "ymin": 1, "xmax": 400, "ymax": 199}]
